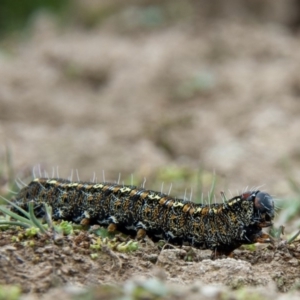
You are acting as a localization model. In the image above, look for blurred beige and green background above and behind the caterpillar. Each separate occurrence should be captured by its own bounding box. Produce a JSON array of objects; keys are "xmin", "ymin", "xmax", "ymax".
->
[{"xmin": 0, "ymin": 0, "xmax": 300, "ymax": 211}]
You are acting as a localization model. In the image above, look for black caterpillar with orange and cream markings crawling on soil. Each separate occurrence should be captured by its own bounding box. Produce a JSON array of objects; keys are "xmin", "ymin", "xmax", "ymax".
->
[{"xmin": 13, "ymin": 178, "xmax": 275, "ymax": 256}]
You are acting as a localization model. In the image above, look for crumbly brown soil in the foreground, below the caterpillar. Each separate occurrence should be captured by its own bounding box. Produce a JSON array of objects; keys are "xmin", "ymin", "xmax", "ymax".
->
[{"xmin": 0, "ymin": 226, "xmax": 300, "ymax": 299}]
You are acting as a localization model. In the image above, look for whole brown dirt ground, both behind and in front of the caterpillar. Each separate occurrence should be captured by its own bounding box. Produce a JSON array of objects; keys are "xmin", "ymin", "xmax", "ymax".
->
[{"xmin": 0, "ymin": 1, "xmax": 300, "ymax": 299}]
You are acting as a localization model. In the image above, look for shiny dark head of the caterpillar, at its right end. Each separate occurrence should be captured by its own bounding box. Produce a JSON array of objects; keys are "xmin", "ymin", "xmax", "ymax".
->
[{"xmin": 242, "ymin": 191, "xmax": 275, "ymax": 227}]
